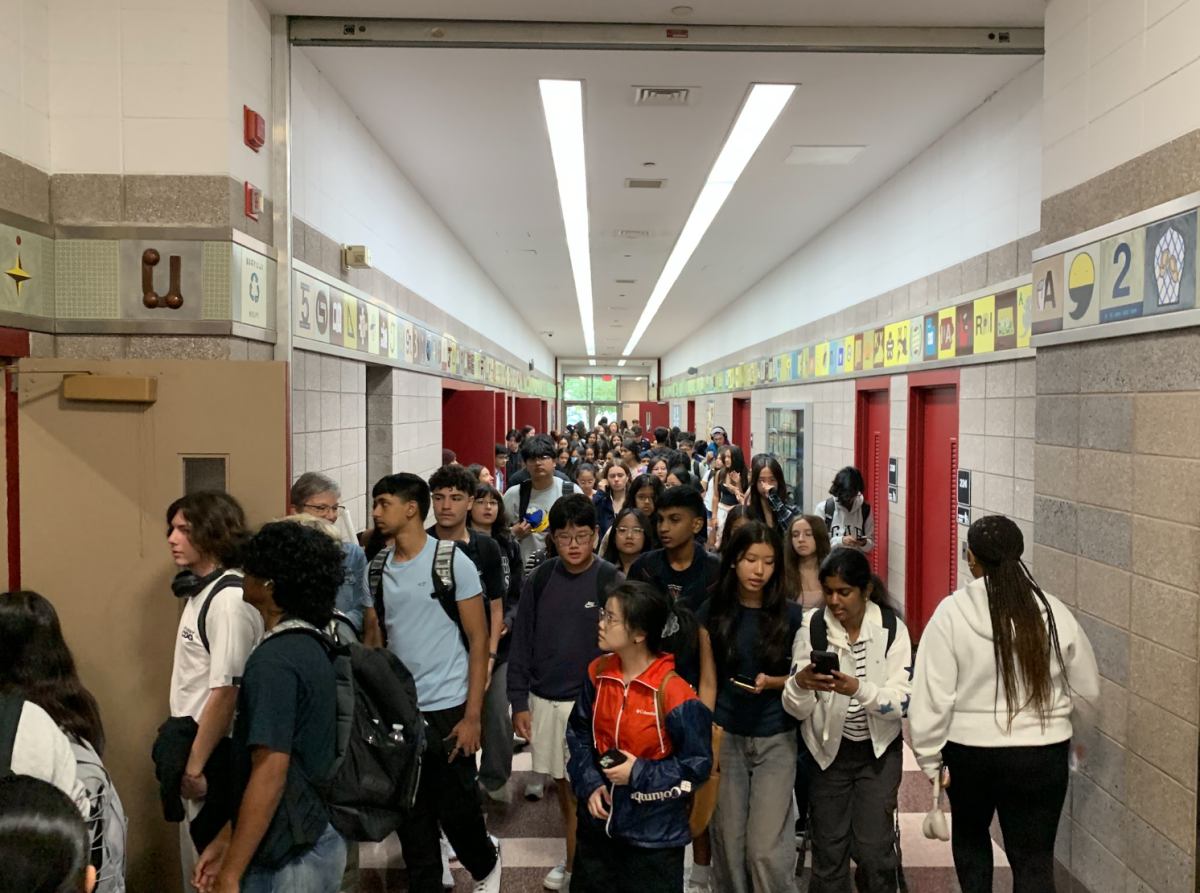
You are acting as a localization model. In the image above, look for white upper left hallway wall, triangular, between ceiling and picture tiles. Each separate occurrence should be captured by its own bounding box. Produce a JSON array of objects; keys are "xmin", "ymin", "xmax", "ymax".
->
[{"xmin": 292, "ymin": 48, "xmax": 554, "ymax": 370}]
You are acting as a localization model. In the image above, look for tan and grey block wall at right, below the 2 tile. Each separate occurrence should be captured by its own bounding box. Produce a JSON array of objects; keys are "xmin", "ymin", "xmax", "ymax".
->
[{"xmin": 1033, "ymin": 329, "xmax": 1200, "ymax": 893}]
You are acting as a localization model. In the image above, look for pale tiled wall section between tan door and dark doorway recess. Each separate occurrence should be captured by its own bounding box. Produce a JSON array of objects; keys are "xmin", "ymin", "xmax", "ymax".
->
[{"xmin": 292, "ymin": 350, "xmax": 364, "ymax": 531}]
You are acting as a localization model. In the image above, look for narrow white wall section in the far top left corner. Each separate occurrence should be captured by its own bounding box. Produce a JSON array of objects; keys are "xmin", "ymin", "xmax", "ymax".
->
[{"xmin": 0, "ymin": 0, "xmax": 50, "ymax": 170}]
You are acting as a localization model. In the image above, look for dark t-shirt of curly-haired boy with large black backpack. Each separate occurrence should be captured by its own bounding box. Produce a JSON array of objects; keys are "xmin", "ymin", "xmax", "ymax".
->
[{"xmin": 233, "ymin": 631, "xmax": 337, "ymax": 868}]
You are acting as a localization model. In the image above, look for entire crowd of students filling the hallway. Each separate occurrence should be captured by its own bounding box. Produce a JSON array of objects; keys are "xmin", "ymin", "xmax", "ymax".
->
[{"xmin": 0, "ymin": 420, "xmax": 1098, "ymax": 893}]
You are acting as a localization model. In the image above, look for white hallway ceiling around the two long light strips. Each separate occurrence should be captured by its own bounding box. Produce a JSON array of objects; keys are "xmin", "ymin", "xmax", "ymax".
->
[{"xmin": 302, "ymin": 44, "xmax": 1042, "ymax": 356}]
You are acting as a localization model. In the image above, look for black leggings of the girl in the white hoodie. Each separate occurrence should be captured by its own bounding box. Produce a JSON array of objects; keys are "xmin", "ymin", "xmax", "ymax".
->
[{"xmin": 942, "ymin": 741, "xmax": 1070, "ymax": 893}]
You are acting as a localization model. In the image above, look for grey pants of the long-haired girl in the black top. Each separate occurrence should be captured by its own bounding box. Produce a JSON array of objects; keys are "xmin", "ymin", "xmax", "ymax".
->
[{"xmin": 713, "ymin": 730, "xmax": 796, "ymax": 893}]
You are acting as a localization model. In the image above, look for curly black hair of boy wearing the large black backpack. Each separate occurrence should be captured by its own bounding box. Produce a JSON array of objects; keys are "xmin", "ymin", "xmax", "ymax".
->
[{"xmin": 241, "ymin": 521, "xmax": 344, "ymax": 627}]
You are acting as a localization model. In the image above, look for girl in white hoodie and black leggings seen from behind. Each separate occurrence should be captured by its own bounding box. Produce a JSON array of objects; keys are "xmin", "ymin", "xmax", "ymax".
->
[{"xmin": 908, "ymin": 515, "xmax": 1099, "ymax": 893}]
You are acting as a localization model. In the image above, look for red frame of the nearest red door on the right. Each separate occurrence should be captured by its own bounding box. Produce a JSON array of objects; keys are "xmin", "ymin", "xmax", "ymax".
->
[{"xmin": 905, "ymin": 368, "xmax": 961, "ymax": 641}]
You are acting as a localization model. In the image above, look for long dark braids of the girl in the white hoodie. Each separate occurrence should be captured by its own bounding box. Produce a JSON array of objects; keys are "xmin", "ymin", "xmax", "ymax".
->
[{"xmin": 967, "ymin": 515, "xmax": 1067, "ymax": 731}]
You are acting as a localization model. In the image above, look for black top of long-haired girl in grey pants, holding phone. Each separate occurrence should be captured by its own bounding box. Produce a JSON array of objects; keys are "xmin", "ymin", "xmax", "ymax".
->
[{"xmin": 697, "ymin": 601, "xmax": 804, "ymax": 738}]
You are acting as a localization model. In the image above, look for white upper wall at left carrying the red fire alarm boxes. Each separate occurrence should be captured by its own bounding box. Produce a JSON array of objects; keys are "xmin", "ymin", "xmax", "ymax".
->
[{"xmin": 41, "ymin": 0, "xmax": 271, "ymax": 183}]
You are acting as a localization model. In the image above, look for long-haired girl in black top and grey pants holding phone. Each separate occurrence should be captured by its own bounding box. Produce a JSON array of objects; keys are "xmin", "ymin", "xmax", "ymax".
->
[{"xmin": 698, "ymin": 521, "xmax": 803, "ymax": 893}]
